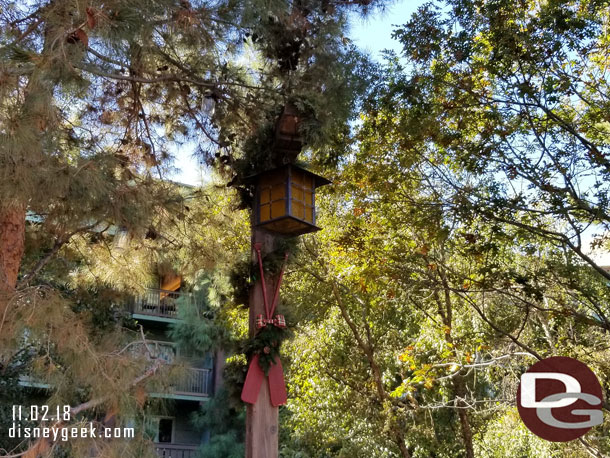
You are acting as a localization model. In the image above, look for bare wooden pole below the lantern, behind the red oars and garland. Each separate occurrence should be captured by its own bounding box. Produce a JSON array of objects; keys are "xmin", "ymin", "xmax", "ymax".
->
[{"xmin": 246, "ymin": 225, "xmax": 279, "ymax": 458}]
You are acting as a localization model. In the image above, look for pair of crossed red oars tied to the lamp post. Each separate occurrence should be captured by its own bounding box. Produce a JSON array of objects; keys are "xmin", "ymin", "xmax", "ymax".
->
[{"xmin": 241, "ymin": 247, "xmax": 288, "ymax": 407}]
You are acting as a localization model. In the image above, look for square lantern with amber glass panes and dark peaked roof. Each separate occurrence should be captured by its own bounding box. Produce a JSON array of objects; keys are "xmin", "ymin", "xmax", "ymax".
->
[{"xmin": 251, "ymin": 164, "xmax": 330, "ymax": 236}]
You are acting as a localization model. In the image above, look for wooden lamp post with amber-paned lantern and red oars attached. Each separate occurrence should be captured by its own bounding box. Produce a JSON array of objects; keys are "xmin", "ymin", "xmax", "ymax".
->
[{"xmin": 242, "ymin": 105, "xmax": 330, "ymax": 458}]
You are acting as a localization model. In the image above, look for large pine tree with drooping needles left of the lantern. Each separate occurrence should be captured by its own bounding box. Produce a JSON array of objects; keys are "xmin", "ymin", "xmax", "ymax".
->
[{"xmin": 0, "ymin": 0, "xmax": 380, "ymax": 456}]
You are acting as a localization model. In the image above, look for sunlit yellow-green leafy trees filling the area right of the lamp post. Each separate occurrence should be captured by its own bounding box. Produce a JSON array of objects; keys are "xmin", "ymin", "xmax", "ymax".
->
[{"xmin": 274, "ymin": 0, "xmax": 610, "ymax": 457}]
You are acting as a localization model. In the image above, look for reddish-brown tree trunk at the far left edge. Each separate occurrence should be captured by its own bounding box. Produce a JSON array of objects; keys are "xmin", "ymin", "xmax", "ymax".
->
[{"xmin": 0, "ymin": 205, "xmax": 25, "ymax": 295}]
